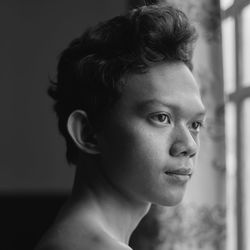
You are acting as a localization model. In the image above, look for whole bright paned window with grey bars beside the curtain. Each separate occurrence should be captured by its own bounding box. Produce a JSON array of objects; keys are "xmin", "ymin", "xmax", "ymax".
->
[{"xmin": 220, "ymin": 0, "xmax": 250, "ymax": 250}]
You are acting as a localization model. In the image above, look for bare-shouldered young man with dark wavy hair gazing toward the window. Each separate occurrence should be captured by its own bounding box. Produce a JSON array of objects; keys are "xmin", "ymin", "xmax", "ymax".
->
[{"xmin": 37, "ymin": 5, "xmax": 204, "ymax": 250}]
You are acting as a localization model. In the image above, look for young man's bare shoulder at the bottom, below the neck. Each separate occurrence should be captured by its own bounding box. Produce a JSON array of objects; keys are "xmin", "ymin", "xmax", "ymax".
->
[{"xmin": 35, "ymin": 198, "xmax": 132, "ymax": 250}]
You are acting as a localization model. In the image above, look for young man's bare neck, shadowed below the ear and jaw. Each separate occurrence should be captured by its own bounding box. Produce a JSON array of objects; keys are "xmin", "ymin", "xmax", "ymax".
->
[{"xmin": 72, "ymin": 156, "xmax": 150, "ymax": 244}]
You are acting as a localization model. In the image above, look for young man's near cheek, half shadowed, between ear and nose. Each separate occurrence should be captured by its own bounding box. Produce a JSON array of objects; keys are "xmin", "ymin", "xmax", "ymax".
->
[{"xmin": 99, "ymin": 122, "xmax": 168, "ymax": 169}]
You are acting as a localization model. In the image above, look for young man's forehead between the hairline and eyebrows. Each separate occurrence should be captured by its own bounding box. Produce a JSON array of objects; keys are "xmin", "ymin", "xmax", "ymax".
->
[{"xmin": 118, "ymin": 63, "xmax": 204, "ymax": 113}]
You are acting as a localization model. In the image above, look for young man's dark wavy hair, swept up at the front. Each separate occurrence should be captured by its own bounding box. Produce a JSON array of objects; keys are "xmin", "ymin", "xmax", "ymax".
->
[{"xmin": 48, "ymin": 5, "xmax": 197, "ymax": 163}]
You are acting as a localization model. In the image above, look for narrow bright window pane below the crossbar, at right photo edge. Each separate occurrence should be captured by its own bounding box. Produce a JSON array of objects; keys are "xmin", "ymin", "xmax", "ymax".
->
[{"xmin": 242, "ymin": 98, "xmax": 250, "ymax": 249}]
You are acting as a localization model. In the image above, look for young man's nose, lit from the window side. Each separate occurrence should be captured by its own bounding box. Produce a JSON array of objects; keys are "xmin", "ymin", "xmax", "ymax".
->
[{"xmin": 170, "ymin": 127, "xmax": 199, "ymax": 158}]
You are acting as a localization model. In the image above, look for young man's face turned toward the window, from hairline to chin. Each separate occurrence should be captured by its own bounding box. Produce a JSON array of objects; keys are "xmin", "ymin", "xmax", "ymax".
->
[{"xmin": 99, "ymin": 63, "xmax": 204, "ymax": 205}]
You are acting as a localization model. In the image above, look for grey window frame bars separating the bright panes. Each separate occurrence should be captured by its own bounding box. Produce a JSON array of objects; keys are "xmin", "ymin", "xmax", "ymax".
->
[{"xmin": 221, "ymin": 0, "xmax": 250, "ymax": 250}]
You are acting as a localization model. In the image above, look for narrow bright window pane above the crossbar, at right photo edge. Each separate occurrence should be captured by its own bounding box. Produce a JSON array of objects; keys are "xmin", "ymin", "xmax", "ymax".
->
[{"xmin": 242, "ymin": 5, "xmax": 250, "ymax": 86}]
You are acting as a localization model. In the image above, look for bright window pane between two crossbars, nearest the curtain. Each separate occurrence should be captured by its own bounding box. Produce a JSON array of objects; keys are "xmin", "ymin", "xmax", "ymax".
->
[{"xmin": 222, "ymin": 17, "xmax": 236, "ymax": 94}]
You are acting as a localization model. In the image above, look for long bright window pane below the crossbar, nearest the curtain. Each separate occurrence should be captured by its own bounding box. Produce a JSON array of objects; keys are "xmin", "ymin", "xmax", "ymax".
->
[{"xmin": 225, "ymin": 103, "xmax": 237, "ymax": 250}]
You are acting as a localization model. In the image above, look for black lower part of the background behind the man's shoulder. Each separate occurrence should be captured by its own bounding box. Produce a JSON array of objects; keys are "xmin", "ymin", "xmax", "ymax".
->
[{"xmin": 0, "ymin": 194, "xmax": 67, "ymax": 250}]
